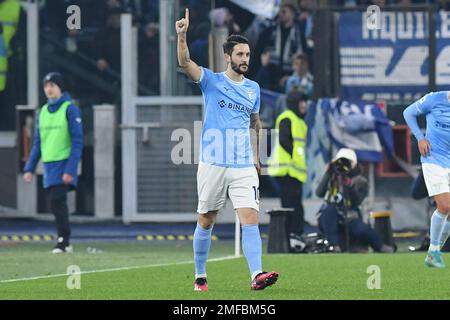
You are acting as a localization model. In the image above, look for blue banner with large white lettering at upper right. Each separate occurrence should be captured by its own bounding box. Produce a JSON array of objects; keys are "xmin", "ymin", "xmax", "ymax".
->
[{"xmin": 339, "ymin": 11, "xmax": 450, "ymax": 101}]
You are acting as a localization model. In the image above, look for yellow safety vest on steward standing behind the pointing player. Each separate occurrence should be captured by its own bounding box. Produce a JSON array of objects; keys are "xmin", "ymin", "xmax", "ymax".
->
[{"xmin": 268, "ymin": 110, "xmax": 308, "ymax": 182}]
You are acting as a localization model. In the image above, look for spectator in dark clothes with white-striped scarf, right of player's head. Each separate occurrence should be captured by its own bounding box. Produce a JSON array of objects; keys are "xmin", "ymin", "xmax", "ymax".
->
[{"xmin": 254, "ymin": 4, "xmax": 307, "ymax": 92}]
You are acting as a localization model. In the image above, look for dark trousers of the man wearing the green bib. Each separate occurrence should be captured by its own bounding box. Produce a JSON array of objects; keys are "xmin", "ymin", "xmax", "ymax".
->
[{"xmin": 46, "ymin": 185, "xmax": 70, "ymax": 242}]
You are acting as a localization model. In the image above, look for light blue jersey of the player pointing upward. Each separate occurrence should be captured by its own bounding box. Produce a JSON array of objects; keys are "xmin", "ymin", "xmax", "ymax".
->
[{"xmin": 198, "ymin": 67, "xmax": 260, "ymax": 168}]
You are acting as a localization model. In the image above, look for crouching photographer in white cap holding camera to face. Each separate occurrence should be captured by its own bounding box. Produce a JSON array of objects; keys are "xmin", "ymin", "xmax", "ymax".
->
[{"xmin": 316, "ymin": 148, "xmax": 394, "ymax": 252}]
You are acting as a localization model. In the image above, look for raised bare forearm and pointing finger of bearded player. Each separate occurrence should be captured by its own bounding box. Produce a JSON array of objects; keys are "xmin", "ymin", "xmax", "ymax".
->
[{"xmin": 175, "ymin": 8, "xmax": 202, "ymax": 82}]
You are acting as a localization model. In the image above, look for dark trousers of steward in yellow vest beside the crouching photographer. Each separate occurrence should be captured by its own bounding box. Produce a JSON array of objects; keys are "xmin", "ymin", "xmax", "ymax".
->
[{"xmin": 277, "ymin": 176, "xmax": 305, "ymax": 235}]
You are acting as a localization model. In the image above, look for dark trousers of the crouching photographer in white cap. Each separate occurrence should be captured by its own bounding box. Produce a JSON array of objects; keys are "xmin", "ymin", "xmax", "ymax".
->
[{"xmin": 319, "ymin": 204, "xmax": 383, "ymax": 252}]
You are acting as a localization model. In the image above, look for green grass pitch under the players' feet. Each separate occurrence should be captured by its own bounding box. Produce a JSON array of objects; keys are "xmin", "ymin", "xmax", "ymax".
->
[{"xmin": 0, "ymin": 241, "xmax": 450, "ymax": 300}]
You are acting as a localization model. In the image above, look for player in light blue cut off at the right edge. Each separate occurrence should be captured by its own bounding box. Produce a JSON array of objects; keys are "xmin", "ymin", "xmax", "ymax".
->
[{"xmin": 403, "ymin": 91, "xmax": 450, "ymax": 268}]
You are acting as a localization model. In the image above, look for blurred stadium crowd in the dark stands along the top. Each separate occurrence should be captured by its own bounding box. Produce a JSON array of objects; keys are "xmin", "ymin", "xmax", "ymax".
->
[{"xmin": 0, "ymin": 0, "xmax": 450, "ymax": 125}]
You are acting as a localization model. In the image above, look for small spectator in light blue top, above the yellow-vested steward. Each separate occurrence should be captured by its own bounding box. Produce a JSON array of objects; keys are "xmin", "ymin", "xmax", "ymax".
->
[{"xmin": 285, "ymin": 53, "xmax": 313, "ymax": 97}]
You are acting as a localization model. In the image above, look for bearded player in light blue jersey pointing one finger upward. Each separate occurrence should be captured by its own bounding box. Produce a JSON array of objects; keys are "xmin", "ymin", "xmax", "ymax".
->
[{"xmin": 175, "ymin": 9, "xmax": 278, "ymax": 291}]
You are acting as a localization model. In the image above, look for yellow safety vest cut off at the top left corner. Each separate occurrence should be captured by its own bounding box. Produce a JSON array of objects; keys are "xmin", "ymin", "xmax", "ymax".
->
[{"xmin": 0, "ymin": 0, "xmax": 20, "ymax": 91}]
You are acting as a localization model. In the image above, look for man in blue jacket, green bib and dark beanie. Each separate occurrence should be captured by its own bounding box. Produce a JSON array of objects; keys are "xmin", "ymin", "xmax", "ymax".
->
[{"xmin": 24, "ymin": 72, "xmax": 83, "ymax": 253}]
